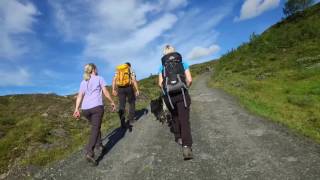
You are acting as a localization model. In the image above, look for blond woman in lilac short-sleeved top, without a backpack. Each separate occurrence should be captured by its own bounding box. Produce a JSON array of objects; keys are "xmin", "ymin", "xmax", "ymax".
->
[{"xmin": 73, "ymin": 63, "xmax": 116, "ymax": 164}]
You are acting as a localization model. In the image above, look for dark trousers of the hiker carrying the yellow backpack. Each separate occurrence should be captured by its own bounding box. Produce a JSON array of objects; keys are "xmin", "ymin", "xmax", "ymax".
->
[{"xmin": 118, "ymin": 86, "xmax": 136, "ymax": 126}]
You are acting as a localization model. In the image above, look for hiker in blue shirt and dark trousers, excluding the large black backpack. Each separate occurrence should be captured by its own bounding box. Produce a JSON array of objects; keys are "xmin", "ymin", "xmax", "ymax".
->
[{"xmin": 158, "ymin": 45, "xmax": 193, "ymax": 160}]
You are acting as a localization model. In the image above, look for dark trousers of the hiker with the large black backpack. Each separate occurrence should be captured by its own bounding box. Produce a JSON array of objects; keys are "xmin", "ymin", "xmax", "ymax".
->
[{"xmin": 164, "ymin": 91, "xmax": 192, "ymax": 147}]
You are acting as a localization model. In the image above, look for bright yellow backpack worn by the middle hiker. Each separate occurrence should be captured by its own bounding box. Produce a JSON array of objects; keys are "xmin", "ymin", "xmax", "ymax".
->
[{"xmin": 116, "ymin": 64, "xmax": 131, "ymax": 87}]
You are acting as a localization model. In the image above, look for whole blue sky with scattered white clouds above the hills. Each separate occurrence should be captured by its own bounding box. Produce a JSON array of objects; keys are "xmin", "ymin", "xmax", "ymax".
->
[{"xmin": 0, "ymin": 0, "xmax": 319, "ymax": 95}]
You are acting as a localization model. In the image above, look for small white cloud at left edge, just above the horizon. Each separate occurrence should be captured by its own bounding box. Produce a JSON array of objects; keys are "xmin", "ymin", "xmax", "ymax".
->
[{"xmin": 0, "ymin": 68, "xmax": 31, "ymax": 87}]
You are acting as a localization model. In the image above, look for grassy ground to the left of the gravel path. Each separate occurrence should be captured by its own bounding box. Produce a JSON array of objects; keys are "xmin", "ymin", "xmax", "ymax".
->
[{"xmin": 0, "ymin": 94, "xmax": 117, "ymax": 176}]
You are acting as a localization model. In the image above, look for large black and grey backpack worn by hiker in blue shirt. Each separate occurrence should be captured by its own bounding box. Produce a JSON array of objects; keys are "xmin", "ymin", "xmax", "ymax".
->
[{"xmin": 161, "ymin": 52, "xmax": 187, "ymax": 109}]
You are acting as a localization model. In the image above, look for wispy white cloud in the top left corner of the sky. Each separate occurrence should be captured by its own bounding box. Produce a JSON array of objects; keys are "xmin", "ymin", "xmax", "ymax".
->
[{"xmin": 0, "ymin": 0, "xmax": 38, "ymax": 59}]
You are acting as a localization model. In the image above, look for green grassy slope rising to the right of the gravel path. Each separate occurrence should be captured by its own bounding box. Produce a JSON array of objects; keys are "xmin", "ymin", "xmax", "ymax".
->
[{"xmin": 211, "ymin": 4, "xmax": 320, "ymax": 142}]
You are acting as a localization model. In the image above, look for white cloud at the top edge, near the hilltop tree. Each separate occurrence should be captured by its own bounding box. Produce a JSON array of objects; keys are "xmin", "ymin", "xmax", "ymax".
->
[{"xmin": 235, "ymin": 0, "xmax": 280, "ymax": 21}]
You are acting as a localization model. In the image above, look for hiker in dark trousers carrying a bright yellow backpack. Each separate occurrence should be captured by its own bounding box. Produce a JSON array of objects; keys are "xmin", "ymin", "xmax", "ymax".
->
[{"xmin": 112, "ymin": 62, "xmax": 140, "ymax": 129}]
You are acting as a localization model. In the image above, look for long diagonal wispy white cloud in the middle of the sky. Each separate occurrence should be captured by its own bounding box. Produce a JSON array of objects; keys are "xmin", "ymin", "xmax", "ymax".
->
[{"xmin": 85, "ymin": 14, "xmax": 177, "ymax": 64}]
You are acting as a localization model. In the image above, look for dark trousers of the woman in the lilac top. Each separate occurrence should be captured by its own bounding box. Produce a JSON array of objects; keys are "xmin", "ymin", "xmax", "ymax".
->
[{"xmin": 83, "ymin": 106, "xmax": 104, "ymax": 156}]
